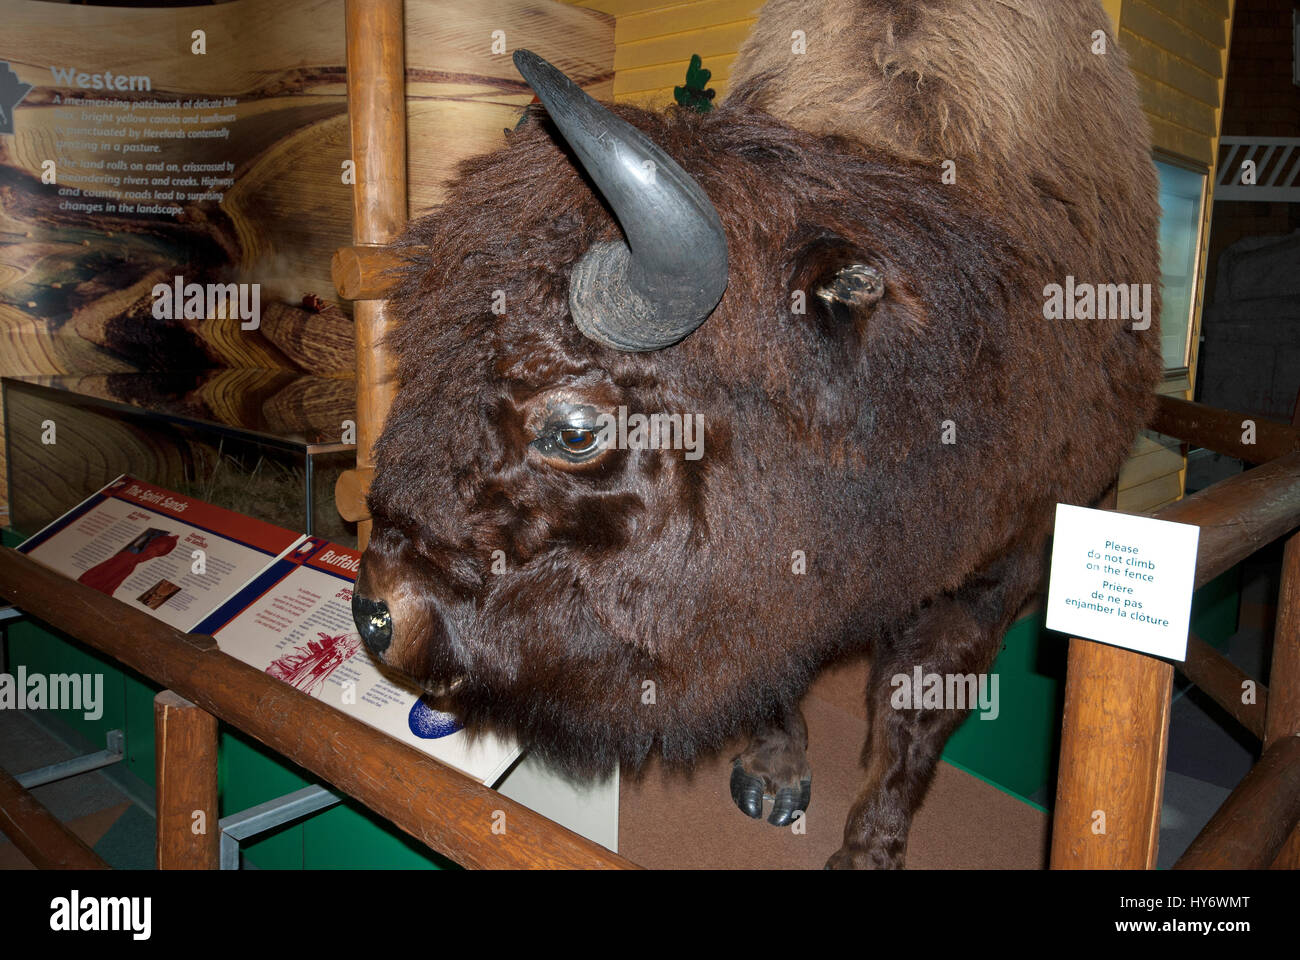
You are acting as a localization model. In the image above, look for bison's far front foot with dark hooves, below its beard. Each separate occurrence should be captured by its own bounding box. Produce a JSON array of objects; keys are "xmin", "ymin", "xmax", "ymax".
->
[{"xmin": 731, "ymin": 708, "xmax": 813, "ymax": 826}]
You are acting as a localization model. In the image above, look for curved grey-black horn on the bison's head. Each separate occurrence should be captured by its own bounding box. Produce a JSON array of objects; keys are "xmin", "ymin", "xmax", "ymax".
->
[{"xmin": 515, "ymin": 49, "xmax": 727, "ymax": 351}]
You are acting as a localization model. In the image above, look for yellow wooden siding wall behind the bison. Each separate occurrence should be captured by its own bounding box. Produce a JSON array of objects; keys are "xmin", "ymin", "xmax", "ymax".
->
[{"xmin": 566, "ymin": 0, "xmax": 1235, "ymax": 511}]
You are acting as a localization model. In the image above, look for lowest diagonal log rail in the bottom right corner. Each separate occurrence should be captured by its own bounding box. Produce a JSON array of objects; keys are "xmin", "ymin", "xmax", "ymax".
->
[{"xmin": 1174, "ymin": 736, "xmax": 1300, "ymax": 870}]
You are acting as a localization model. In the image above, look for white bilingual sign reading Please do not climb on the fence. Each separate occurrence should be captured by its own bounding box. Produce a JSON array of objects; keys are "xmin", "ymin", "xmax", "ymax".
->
[{"xmin": 1047, "ymin": 503, "xmax": 1201, "ymax": 661}]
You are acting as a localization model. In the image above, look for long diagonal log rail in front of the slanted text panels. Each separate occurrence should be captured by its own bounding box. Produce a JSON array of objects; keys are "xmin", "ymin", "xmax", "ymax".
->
[{"xmin": 0, "ymin": 548, "xmax": 634, "ymax": 869}]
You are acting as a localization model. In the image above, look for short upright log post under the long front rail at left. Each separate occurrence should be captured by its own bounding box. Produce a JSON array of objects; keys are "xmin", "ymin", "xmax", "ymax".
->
[{"xmin": 153, "ymin": 689, "xmax": 221, "ymax": 870}]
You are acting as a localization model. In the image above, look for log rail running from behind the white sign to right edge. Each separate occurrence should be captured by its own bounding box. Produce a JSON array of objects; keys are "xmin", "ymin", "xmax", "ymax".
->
[{"xmin": 1151, "ymin": 453, "xmax": 1300, "ymax": 587}]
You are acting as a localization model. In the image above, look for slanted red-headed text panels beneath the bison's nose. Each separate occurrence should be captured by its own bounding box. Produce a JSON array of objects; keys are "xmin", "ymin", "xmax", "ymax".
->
[{"xmin": 18, "ymin": 475, "xmax": 520, "ymax": 784}]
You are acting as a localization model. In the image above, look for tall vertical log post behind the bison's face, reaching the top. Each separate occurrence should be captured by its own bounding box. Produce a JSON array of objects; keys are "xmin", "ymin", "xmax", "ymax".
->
[{"xmin": 341, "ymin": 0, "xmax": 407, "ymax": 549}]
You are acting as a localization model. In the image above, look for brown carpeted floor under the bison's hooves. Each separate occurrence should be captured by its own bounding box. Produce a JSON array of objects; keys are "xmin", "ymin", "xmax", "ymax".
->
[{"xmin": 619, "ymin": 663, "xmax": 1049, "ymax": 869}]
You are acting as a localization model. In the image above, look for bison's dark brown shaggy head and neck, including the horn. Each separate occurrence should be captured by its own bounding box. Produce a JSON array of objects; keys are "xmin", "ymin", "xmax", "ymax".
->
[{"xmin": 354, "ymin": 53, "xmax": 1145, "ymax": 773}]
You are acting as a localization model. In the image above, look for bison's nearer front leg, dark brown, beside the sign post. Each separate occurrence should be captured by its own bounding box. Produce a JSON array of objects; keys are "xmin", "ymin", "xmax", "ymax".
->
[{"xmin": 827, "ymin": 546, "xmax": 1041, "ymax": 869}]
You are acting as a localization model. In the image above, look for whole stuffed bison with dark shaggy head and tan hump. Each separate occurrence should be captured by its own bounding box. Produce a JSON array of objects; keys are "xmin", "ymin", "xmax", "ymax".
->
[{"xmin": 354, "ymin": 0, "xmax": 1161, "ymax": 866}]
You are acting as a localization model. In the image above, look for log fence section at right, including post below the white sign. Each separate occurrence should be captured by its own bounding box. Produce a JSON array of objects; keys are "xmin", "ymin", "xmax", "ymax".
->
[{"xmin": 1052, "ymin": 397, "xmax": 1300, "ymax": 869}]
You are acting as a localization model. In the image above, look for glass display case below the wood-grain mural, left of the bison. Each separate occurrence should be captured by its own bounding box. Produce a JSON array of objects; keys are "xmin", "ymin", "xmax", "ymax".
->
[{"xmin": 0, "ymin": 369, "xmax": 356, "ymax": 545}]
